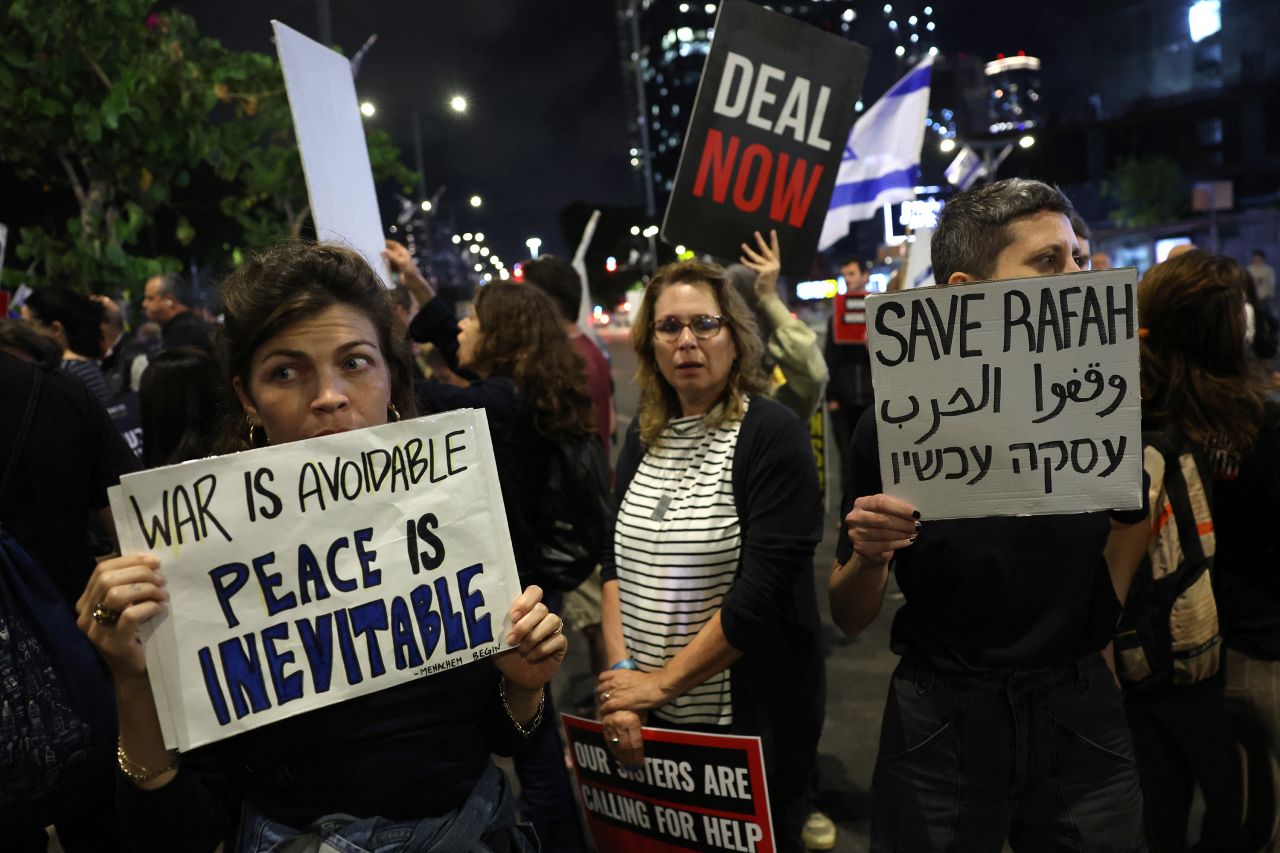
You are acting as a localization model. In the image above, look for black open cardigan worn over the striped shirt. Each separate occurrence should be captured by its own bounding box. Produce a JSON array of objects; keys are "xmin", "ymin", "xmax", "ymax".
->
[{"xmin": 600, "ymin": 396, "xmax": 826, "ymax": 790}]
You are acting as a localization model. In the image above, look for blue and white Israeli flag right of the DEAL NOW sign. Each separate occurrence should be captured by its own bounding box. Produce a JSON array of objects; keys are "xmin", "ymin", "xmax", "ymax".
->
[{"xmin": 818, "ymin": 56, "xmax": 933, "ymax": 250}]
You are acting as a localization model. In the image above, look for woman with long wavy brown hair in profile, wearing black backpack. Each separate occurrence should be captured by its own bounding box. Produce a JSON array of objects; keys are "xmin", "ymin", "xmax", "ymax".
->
[{"xmin": 385, "ymin": 247, "xmax": 596, "ymax": 853}]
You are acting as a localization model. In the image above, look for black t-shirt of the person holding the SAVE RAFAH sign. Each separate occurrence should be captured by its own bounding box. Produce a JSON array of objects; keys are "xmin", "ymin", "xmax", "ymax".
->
[{"xmin": 836, "ymin": 409, "xmax": 1130, "ymax": 671}]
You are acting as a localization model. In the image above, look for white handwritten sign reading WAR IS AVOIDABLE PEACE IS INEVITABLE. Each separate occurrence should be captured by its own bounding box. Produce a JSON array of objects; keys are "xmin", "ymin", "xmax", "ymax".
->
[{"xmin": 111, "ymin": 410, "xmax": 520, "ymax": 749}]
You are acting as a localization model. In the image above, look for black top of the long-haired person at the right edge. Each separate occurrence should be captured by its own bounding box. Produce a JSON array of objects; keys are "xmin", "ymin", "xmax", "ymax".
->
[{"xmin": 1213, "ymin": 405, "xmax": 1280, "ymax": 661}]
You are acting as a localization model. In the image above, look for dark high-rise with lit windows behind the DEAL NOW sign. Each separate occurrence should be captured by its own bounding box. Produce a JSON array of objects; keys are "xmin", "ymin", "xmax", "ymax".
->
[{"xmin": 618, "ymin": 0, "xmax": 936, "ymax": 219}]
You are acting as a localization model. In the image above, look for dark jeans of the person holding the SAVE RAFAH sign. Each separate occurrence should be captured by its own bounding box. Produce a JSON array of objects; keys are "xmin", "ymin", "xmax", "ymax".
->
[{"xmin": 872, "ymin": 654, "xmax": 1147, "ymax": 853}]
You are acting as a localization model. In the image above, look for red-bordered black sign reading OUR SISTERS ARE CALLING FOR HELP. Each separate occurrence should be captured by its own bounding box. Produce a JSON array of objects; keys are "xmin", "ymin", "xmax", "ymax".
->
[{"xmin": 561, "ymin": 715, "xmax": 774, "ymax": 853}]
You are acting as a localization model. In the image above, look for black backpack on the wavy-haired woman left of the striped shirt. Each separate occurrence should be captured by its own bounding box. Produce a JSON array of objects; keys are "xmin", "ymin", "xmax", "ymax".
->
[{"xmin": 534, "ymin": 433, "xmax": 613, "ymax": 592}]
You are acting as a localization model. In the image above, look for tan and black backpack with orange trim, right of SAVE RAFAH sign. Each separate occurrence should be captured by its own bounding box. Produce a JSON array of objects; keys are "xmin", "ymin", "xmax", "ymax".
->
[{"xmin": 1115, "ymin": 432, "xmax": 1222, "ymax": 699}]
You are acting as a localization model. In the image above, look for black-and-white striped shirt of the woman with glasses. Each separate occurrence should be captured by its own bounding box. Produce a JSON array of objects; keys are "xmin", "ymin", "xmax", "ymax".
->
[{"xmin": 613, "ymin": 406, "xmax": 745, "ymax": 726}]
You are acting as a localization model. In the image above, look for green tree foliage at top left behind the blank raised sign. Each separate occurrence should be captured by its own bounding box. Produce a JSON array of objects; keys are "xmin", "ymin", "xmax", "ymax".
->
[{"xmin": 0, "ymin": 0, "xmax": 415, "ymax": 289}]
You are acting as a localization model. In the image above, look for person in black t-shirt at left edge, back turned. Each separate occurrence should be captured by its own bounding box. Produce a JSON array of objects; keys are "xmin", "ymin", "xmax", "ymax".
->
[{"xmin": 0, "ymin": 319, "xmax": 137, "ymax": 853}]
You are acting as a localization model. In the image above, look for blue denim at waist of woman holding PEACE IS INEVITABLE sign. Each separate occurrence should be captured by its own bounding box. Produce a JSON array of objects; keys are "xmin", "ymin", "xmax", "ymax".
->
[{"xmin": 237, "ymin": 762, "xmax": 539, "ymax": 853}]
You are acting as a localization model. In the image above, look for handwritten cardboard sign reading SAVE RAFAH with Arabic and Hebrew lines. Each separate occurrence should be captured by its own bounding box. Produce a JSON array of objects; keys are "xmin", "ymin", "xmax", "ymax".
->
[{"xmin": 867, "ymin": 268, "xmax": 1142, "ymax": 519}]
